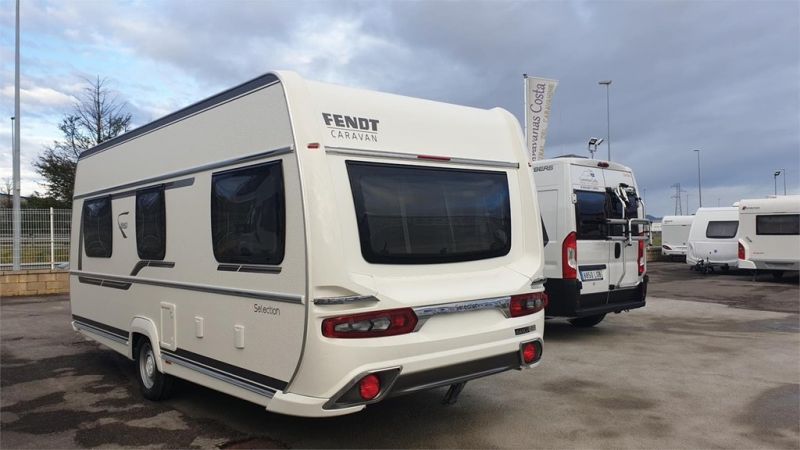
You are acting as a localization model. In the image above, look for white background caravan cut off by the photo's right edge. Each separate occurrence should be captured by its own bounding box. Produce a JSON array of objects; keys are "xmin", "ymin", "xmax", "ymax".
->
[{"xmin": 738, "ymin": 195, "xmax": 800, "ymax": 278}]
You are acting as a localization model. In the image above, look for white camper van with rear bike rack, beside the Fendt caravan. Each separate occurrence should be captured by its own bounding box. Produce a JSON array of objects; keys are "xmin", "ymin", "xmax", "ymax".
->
[{"xmin": 533, "ymin": 155, "xmax": 649, "ymax": 327}]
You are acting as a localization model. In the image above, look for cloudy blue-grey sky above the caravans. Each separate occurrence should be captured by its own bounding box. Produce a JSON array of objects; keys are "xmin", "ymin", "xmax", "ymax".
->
[{"xmin": 0, "ymin": 0, "xmax": 800, "ymax": 216}]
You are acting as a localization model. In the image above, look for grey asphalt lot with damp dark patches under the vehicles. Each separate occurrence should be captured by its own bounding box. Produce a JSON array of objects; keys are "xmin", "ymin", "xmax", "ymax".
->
[{"xmin": 0, "ymin": 263, "xmax": 800, "ymax": 449}]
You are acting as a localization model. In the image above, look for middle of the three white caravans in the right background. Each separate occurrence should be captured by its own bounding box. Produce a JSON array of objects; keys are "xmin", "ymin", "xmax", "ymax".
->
[{"xmin": 686, "ymin": 206, "xmax": 739, "ymax": 272}]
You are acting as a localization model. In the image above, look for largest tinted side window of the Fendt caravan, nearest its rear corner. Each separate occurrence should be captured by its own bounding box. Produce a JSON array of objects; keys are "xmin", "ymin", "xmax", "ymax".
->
[{"xmin": 211, "ymin": 161, "xmax": 286, "ymax": 264}]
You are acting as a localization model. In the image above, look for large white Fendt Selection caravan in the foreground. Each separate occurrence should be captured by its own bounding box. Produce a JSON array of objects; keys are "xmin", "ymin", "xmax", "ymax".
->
[{"xmin": 70, "ymin": 72, "xmax": 547, "ymax": 417}]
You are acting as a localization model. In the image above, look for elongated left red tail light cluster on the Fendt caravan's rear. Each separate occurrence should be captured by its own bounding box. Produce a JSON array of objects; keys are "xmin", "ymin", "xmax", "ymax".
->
[{"xmin": 322, "ymin": 308, "xmax": 417, "ymax": 339}]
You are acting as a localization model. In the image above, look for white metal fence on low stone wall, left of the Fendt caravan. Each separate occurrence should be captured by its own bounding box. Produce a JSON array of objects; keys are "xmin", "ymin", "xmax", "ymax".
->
[{"xmin": 0, "ymin": 208, "xmax": 72, "ymax": 270}]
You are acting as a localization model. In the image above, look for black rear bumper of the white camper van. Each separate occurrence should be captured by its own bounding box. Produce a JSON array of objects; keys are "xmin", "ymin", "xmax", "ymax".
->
[{"xmin": 545, "ymin": 275, "xmax": 649, "ymax": 317}]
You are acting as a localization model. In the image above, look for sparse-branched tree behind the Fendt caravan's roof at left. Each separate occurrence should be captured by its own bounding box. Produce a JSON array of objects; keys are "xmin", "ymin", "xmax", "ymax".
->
[{"xmin": 33, "ymin": 76, "xmax": 132, "ymax": 207}]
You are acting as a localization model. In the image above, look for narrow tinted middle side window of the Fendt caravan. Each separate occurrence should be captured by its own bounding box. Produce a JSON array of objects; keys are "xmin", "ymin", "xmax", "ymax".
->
[{"xmin": 136, "ymin": 186, "xmax": 167, "ymax": 260}]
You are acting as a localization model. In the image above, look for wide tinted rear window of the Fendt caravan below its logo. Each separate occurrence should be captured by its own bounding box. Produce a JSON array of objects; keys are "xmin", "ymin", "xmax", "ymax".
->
[{"xmin": 347, "ymin": 161, "xmax": 511, "ymax": 264}]
